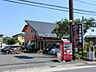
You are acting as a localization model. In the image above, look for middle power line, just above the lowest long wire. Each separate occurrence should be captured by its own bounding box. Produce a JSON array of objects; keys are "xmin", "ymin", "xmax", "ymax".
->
[{"xmin": 19, "ymin": 0, "xmax": 96, "ymax": 13}]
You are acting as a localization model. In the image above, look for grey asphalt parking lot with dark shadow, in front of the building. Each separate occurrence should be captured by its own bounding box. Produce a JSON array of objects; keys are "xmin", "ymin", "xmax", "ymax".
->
[{"xmin": 0, "ymin": 53, "xmax": 56, "ymax": 65}]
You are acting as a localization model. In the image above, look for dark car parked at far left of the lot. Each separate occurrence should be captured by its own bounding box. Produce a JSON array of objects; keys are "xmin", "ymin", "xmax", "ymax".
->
[{"xmin": 1, "ymin": 46, "xmax": 21, "ymax": 54}]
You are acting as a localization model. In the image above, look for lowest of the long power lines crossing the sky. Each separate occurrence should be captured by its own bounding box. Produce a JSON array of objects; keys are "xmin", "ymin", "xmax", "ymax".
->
[{"xmin": 4, "ymin": 0, "xmax": 96, "ymax": 16}]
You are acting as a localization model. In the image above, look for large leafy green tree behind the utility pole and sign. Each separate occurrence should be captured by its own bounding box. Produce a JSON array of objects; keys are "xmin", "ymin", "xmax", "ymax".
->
[{"xmin": 54, "ymin": 17, "xmax": 96, "ymax": 38}]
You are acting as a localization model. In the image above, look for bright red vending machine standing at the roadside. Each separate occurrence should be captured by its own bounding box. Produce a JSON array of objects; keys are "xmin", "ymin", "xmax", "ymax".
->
[{"xmin": 60, "ymin": 42, "xmax": 72, "ymax": 61}]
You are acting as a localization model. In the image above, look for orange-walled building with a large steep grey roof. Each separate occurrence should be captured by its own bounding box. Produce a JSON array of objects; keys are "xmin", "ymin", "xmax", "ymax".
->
[{"xmin": 22, "ymin": 20, "xmax": 62, "ymax": 49}]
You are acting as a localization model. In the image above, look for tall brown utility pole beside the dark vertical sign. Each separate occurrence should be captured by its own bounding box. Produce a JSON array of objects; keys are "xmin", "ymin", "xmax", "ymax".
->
[{"xmin": 69, "ymin": 0, "xmax": 75, "ymax": 60}]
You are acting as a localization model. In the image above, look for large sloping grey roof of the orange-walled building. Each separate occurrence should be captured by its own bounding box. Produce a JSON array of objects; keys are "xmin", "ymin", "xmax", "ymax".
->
[{"xmin": 25, "ymin": 20, "xmax": 56, "ymax": 37}]
